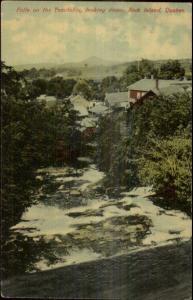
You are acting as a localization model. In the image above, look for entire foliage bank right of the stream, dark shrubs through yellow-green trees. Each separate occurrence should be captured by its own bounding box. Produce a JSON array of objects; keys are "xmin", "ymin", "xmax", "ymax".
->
[{"xmin": 98, "ymin": 93, "xmax": 192, "ymax": 213}]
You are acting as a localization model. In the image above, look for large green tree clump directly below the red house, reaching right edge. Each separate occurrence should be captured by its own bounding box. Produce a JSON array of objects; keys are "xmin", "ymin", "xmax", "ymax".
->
[{"xmin": 128, "ymin": 93, "xmax": 192, "ymax": 213}]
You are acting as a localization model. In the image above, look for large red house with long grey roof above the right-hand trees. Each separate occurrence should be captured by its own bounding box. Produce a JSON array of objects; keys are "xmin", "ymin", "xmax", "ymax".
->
[{"xmin": 128, "ymin": 77, "xmax": 192, "ymax": 103}]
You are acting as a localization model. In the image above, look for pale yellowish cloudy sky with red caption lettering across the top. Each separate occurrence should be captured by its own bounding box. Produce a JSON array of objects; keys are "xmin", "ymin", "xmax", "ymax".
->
[{"xmin": 1, "ymin": 1, "xmax": 192, "ymax": 65}]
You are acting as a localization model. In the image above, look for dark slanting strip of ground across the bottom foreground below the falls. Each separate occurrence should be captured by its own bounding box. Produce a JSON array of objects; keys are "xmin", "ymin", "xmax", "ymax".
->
[{"xmin": 2, "ymin": 241, "xmax": 191, "ymax": 300}]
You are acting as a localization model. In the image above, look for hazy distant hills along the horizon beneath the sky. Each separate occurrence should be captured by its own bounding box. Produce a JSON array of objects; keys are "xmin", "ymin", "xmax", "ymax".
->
[{"xmin": 14, "ymin": 56, "xmax": 192, "ymax": 79}]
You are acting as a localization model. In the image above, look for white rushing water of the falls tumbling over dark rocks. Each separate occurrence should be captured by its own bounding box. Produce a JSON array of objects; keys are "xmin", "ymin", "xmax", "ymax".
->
[{"xmin": 9, "ymin": 158, "xmax": 191, "ymax": 274}]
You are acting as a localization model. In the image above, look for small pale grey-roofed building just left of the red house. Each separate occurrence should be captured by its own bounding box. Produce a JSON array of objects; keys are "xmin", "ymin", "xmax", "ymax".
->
[{"xmin": 105, "ymin": 92, "xmax": 129, "ymax": 109}]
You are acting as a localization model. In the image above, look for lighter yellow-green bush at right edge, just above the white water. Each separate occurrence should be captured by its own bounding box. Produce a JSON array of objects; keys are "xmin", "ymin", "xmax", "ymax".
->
[{"xmin": 138, "ymin": 135, "xmax": 192, "ymax": 214}]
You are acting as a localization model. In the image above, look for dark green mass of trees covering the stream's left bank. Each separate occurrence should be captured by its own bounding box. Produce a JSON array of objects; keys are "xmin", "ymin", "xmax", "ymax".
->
[{"xmin": 1, "ymin": 64, "xmax": 80, "ymax": 237}]
